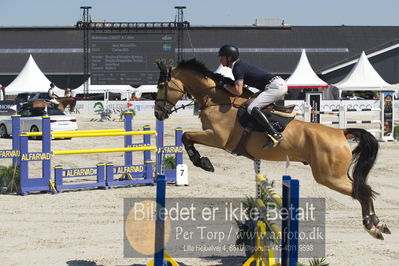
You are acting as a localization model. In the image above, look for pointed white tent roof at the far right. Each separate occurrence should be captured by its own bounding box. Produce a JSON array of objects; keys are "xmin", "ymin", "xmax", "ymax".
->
[{"xmin": 334, "ymin": 52, "xmax": 395, "ymax": 91}]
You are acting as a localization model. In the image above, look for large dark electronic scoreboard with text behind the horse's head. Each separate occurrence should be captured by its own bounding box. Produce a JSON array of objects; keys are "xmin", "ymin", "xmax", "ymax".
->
[{"xmin": 90, "ymin": 33, "xmax": 177, "ymax": 86}]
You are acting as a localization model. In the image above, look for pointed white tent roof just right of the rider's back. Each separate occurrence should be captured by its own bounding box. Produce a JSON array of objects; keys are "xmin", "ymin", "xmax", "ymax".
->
[{"xmin": 286, "ymin": 49, "xmax": 328, "ymax": 89}]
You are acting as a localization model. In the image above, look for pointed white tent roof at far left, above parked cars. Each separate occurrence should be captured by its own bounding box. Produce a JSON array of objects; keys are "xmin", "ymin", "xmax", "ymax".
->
[{"xmin": 5, "ymin": 55, "xmax": 56, "ymax": 95}]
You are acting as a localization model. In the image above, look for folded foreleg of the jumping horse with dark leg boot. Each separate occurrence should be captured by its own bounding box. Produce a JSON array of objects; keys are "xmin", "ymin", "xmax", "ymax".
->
[{"xmin": 182, "ymin": 129, "xmax": 220, "ymax": 172}]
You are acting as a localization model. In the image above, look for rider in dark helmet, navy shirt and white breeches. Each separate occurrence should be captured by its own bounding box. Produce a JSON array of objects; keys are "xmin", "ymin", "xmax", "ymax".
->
[{"xmin": 218, "ymin": 45, "xmax": 288, "ymax": 148}]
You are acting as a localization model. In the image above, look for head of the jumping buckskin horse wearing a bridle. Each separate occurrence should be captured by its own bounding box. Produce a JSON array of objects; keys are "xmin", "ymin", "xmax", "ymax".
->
[{"xmin": 154, "ymin": 62, "xmax": 186, "ymax": 121}]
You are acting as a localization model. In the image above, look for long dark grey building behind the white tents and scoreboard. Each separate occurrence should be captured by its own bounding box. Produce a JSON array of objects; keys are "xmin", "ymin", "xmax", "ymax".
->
[{"xmin": 0, "ymin": 24, "xmax": 399, "ymax": 95}]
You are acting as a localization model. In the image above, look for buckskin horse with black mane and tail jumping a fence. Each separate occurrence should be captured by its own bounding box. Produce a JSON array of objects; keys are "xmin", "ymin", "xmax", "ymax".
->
[{"xmin": 154, "ymin": 59, "xmax": 390, "ymax": 239}]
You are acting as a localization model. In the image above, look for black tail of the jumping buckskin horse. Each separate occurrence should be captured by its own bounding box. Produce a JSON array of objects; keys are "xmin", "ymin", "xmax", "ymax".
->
[{"xmin": 344, "ymin": 128, "xmax": 378, "ymax": 199}]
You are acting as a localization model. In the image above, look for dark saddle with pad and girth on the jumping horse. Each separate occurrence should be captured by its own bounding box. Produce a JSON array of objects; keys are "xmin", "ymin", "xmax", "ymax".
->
[{"xmin": 232, "ymin": 98, "xmax": 296, "ymax": 159}]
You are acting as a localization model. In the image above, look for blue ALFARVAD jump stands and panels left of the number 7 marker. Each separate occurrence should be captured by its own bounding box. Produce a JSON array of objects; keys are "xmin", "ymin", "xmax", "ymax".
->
[{"xmin": 0, "ymin": 113, "xmax": 183, "ymax": 195}]
